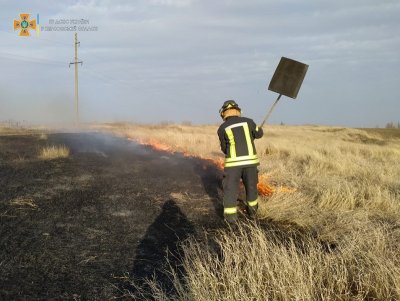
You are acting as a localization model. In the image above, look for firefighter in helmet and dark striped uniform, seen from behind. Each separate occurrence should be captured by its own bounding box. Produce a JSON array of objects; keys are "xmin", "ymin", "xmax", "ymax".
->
[{"xmin": 218, "ymin": 100, "xmax": 263, "ymax": 223}]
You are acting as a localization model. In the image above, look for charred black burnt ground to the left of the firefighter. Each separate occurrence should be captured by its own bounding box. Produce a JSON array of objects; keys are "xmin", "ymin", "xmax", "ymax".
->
[{"xmin": 0, "ymin": 133, "xmax": 221, "ymax": 300}]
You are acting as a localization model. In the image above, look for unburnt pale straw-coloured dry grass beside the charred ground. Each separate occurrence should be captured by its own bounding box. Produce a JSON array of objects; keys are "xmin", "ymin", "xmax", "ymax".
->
[{"xmin": 96, "ymin": 124, "xmax": 400, "ymax": 300}]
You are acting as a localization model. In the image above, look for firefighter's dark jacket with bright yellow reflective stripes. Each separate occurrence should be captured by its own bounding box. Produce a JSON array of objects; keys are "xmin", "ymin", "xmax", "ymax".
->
[{"xmin": 218, "ymin": 116, "xmax": 263, "ymax": 168}]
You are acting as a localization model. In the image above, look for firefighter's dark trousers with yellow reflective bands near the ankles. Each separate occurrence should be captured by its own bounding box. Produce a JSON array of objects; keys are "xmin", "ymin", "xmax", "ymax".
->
[{"xmin": 222, "ymin": 166, "xmax": 258, "ymax": 222}]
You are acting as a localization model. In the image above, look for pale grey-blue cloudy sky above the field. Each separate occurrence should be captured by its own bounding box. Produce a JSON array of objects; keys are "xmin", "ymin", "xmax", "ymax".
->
[{"xmin": 0, "ymin": 0, "xmax": 400, "ymax": 127}]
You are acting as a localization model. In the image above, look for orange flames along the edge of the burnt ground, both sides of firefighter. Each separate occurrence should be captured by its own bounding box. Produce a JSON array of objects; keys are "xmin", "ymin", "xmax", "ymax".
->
[{"xmin": 128, "ymin": 137, "xmax": 296, "ymax": 196}]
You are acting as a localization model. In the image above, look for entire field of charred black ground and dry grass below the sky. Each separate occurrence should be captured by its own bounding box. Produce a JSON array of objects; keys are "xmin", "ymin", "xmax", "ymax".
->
[{"xmin": 0, "ymin": 124, "xmax": 400, "ymax": 300}]
